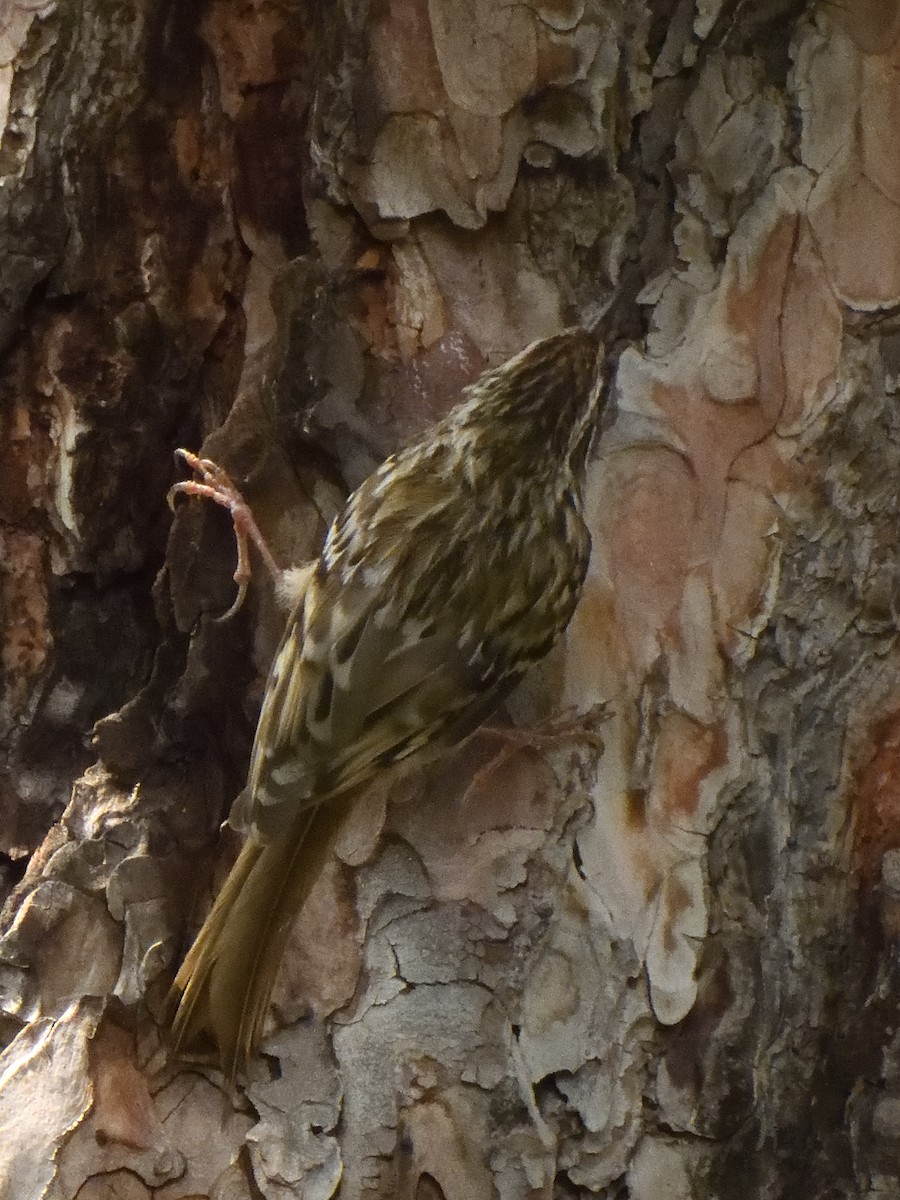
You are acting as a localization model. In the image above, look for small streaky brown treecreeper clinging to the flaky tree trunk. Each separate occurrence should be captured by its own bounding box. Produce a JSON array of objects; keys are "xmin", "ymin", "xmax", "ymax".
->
[{"xmin": 168, "ymin": 326, "xmax": 602, "ymax": 1084}]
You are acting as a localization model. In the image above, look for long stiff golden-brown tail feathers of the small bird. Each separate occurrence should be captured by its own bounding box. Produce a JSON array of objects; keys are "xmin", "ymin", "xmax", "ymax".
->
[{"xmin": 168, "ymin": 798, "xmax": 349, "ymax": 1082}]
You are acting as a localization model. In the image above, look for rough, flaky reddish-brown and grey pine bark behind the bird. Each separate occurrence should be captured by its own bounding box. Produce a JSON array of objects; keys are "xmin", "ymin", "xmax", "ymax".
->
[{"xmin": 0, "ymin": 0, "xmax": 900, "ymax": 1200}]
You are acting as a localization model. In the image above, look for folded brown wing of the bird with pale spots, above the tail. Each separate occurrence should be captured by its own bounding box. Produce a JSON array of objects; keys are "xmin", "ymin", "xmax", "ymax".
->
[{"xmin": 240, "ymin": 566, "xmax": 484, "ymax": 840}]
